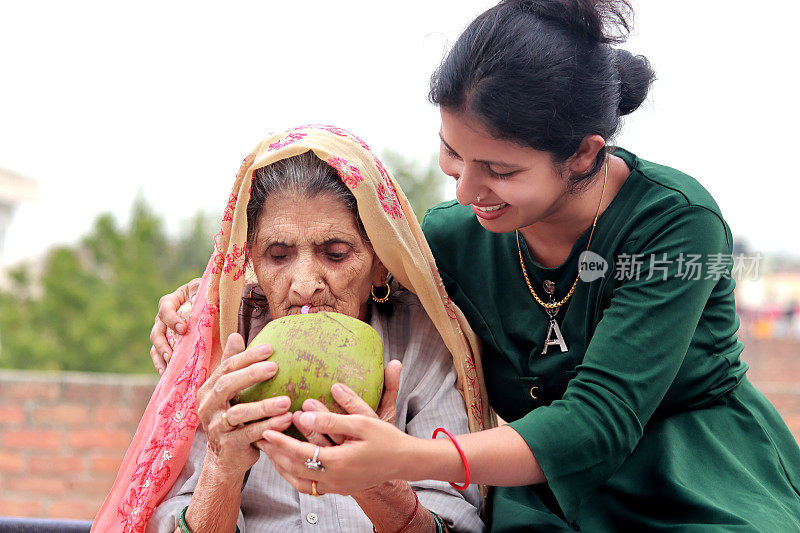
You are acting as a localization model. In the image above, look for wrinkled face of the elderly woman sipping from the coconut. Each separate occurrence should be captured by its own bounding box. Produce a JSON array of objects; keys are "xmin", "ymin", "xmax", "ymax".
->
[{"xmin": 251, "ymin": 193, "xmax": 387, "ymax": 320}]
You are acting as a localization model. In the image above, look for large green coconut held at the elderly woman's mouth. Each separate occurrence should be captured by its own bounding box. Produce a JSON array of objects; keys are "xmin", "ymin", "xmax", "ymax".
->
[{"xmin": 236, "ymin": 312, "xmax": 384, "ymax": 437}]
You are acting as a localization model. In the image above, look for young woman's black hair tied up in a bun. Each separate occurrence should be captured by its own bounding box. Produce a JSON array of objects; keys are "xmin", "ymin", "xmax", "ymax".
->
[{"xmin": 429, "ymin": 0, "xmax": 655, "ymax": 187}]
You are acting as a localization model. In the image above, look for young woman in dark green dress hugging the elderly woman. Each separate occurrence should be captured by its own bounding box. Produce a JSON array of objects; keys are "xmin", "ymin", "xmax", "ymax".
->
[{"xmin": 152, "ymin": 0, "xmax": 800, "ymax": 531}]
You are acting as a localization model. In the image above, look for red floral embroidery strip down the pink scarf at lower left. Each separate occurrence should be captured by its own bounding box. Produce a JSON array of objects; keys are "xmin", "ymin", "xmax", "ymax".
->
[{"xmin": 117, "ymin": 303, "xmax": 219, "ymax": 533}]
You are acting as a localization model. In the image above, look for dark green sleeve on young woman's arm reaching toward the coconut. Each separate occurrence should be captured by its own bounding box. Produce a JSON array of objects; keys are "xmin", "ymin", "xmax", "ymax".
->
[{"xmin": 509, "ymin": 206, "xmax": 731, "ymax": 519}]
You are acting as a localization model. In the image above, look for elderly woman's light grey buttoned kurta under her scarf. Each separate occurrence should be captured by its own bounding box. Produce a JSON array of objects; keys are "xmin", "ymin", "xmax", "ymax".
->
[{"xmin": 147, "ymin": 287, "xmax": 484, "ymax": 533}]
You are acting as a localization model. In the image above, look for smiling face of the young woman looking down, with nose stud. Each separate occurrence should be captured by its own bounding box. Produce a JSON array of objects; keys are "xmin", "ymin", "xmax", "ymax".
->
[{"xmin": 439, "ymin": 107, "xmax": 568, "ymax": 233}]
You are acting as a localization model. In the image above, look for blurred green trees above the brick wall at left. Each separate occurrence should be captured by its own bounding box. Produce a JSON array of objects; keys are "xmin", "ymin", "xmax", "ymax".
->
[{"xmin": 0, "ymin": 194, "xmax": 213, "ymax": 373}]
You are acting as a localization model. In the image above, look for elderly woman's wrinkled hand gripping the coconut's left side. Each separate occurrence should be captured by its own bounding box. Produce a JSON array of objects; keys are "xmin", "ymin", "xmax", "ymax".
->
[{"xmin": 197, "ymin": 333, "xmax": 292, "ymax": 475}]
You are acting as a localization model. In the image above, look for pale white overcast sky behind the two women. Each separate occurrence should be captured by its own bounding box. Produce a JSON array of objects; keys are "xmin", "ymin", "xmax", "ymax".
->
[{"xmin": 0, "ymin": 0, "xmax": 800, "ymax": 263}]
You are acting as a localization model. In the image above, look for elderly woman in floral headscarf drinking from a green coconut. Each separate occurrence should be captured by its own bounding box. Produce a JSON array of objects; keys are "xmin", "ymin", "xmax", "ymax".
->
[{"xmin": 94, "ymin": 126, "xmax": 488, "ymax": 532}]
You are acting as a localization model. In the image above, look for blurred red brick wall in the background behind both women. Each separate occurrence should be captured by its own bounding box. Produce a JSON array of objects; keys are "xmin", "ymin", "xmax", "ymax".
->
[{"xmin": 0, "ymin": 337, "xmax": 800, "ymax": 519}]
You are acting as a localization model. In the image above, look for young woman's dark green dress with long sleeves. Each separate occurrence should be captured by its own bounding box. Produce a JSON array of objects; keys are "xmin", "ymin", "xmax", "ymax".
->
[{"xmin": 423, "ymin": 149, "xmax": 800, "ymax": 532}]
